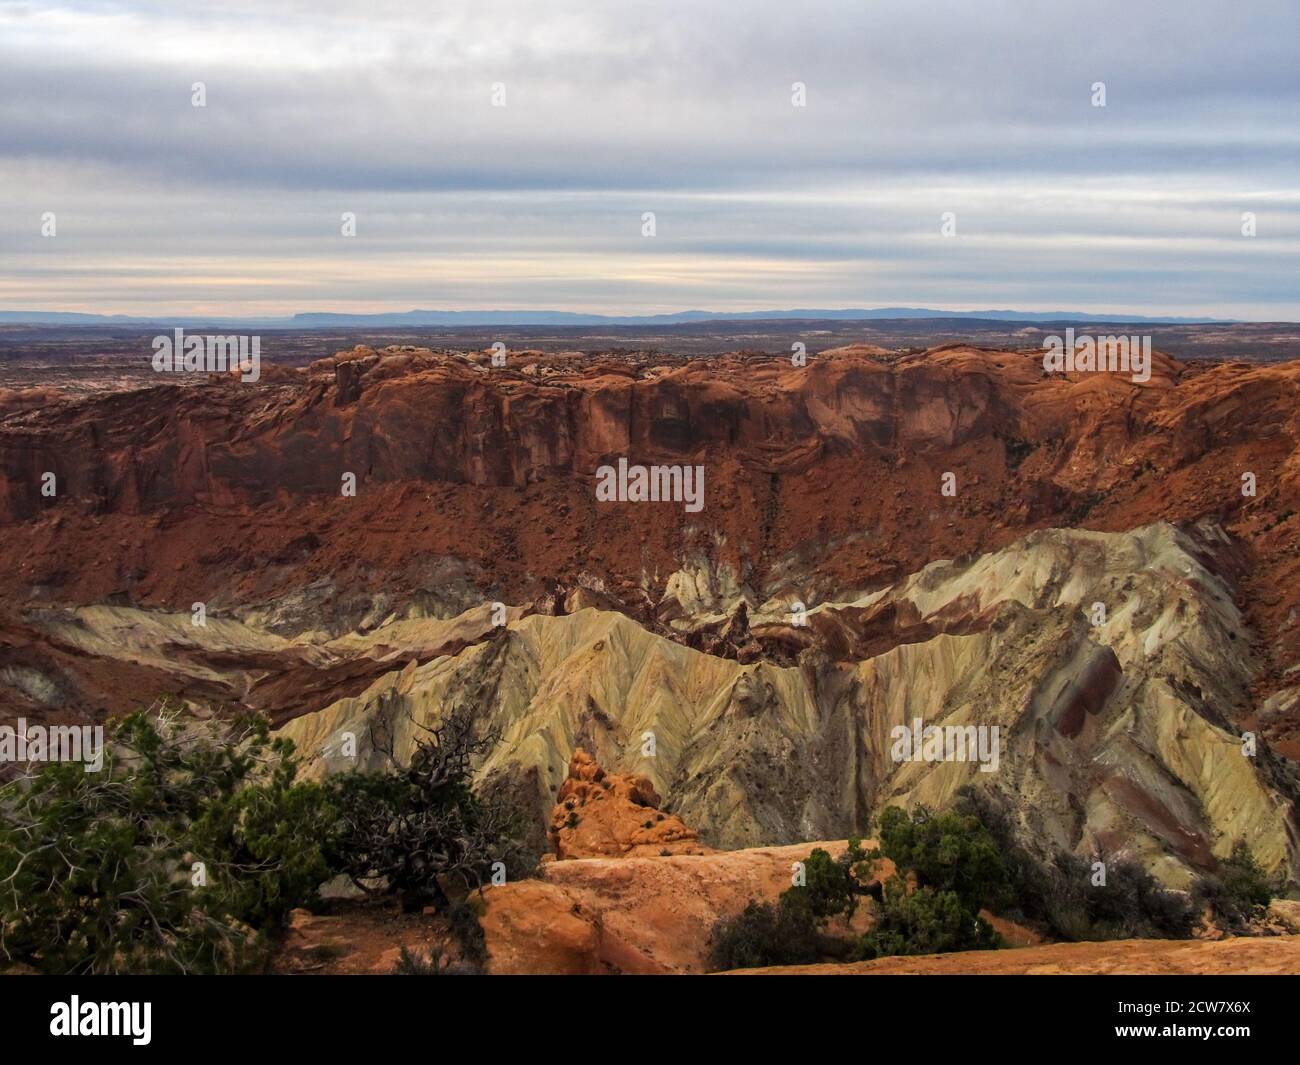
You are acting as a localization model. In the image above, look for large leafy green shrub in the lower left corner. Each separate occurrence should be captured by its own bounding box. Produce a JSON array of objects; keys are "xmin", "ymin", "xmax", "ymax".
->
[{"xmin": 0, "ymin": 707, "xmax": 334, "ymax": 974}]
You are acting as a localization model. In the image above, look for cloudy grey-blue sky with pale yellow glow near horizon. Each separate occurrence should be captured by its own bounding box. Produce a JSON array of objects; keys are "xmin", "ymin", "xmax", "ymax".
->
[{"xmin": 0, "ymin": 0, "xmax": 1300, "ymax": 320}]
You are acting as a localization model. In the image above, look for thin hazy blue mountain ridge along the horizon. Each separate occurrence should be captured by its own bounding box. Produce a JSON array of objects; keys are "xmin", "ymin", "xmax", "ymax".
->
[{"xmin": 0, "ymin": 307, "xmax": 1236, "ymax": 329}]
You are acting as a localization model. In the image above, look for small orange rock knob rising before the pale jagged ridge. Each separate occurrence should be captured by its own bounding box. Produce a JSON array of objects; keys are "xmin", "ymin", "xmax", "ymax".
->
[{"xmin": 549, "ymin": 748, "xmax": 714, "ymax": 860}]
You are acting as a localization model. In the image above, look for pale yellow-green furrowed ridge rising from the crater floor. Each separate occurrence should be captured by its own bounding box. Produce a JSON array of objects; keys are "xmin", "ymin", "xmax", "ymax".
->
[{"xmin": 271, "ymin": 525, "xmax": 1295, "ymax": 884}]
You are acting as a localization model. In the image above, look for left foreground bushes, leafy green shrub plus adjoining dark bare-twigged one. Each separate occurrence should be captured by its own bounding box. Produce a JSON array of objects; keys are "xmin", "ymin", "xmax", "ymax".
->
[{"xmin": 0, "ymin": 706, "xmax": 528, "ymax": 974}]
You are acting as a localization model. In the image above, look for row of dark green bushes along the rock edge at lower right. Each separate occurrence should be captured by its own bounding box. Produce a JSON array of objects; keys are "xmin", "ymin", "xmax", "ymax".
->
[{"xmin": 710, "ymin": 789, "xmax": 1281, "ymax": 970}]
